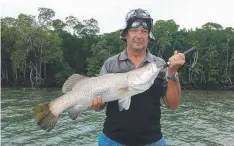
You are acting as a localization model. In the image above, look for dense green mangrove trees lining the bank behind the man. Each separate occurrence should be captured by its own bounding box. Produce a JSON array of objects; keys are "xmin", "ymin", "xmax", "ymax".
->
[{"xmin": 1, "ymin": 8, "xmax": 234, "ymax": 88}]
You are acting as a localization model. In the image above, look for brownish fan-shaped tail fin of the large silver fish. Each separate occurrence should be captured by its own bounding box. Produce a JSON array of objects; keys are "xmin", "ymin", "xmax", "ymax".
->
[{"xmin": 33, "ymin": 103, "xmax": 59, "ymax": 132}]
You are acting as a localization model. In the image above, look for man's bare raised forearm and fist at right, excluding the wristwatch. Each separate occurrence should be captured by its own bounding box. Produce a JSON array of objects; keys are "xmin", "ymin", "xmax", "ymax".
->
[{"xmin": 163, "ymin": 51, "xmax": 185, "ymax": 110}]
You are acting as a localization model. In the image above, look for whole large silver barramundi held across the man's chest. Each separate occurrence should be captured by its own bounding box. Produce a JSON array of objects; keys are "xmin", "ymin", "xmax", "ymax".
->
[{"xmin": 33, "ymin": 62, "xmax": 162, "ymax": 131}]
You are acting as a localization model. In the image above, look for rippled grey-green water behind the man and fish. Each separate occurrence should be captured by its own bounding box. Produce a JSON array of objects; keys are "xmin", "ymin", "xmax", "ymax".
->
[{"xmin": 1, "ymin": 89, "xmax": 234, "ymax": 146}]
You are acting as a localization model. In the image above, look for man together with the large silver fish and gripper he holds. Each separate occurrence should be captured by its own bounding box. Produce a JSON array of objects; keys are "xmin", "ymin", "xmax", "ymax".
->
[{"xmin": 33, "ymin": 9, "xmax": 186, "ymax": 146}]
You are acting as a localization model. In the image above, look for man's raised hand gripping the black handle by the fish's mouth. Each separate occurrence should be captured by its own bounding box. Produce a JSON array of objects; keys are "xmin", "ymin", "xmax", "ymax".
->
[{"xmin": 168, "ymin": 51, "xmax": 185, "ymax": 76}]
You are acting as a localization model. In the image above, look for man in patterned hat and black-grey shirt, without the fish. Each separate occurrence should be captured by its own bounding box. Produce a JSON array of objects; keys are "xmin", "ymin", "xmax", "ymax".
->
[{"xmin": 90, "ymin": 9, "xmax": 185, "ymax": 146}]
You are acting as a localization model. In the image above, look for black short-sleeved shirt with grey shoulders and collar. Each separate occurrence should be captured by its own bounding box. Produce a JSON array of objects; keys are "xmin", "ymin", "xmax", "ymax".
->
[{"xmin": 100, "ymin": 50, "xmax": 167, "ymax": 146}]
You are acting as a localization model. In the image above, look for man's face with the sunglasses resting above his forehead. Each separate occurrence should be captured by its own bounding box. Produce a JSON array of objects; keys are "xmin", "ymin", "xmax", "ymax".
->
[{"xmin": 126, "ymin": 21, "xmax": 149, "ymax": 51}]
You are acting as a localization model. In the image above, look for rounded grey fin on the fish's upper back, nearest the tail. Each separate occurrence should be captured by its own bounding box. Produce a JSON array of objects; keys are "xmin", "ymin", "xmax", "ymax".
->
[{"xmin": 62, "ymin": 74, "xmax": 88, "ymax": 93}]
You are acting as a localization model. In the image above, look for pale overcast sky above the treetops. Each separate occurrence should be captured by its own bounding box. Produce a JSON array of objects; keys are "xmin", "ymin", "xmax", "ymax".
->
[{"xmin": 0, "ymin": 0, "xmax": 234, "ymax": 33}]
